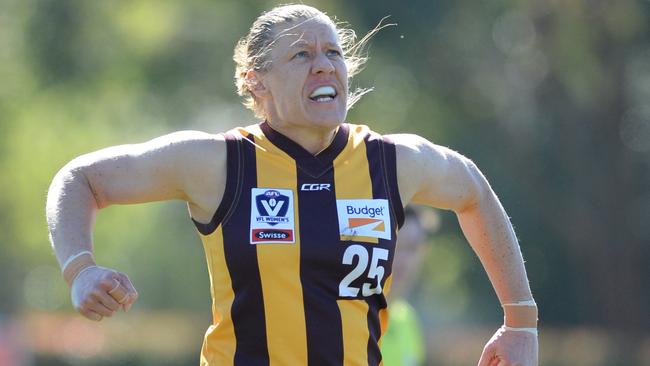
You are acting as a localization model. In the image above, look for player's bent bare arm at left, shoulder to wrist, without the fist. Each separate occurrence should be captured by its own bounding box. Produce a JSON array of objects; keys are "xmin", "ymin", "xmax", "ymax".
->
[{"xmin": 46, "ymin": 131, "xmax": 226, "ymax": 265}]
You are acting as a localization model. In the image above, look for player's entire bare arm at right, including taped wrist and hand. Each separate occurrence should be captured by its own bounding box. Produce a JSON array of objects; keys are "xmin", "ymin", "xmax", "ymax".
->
[{"xmin": 392, "ymin": 135, "xmax": 538, "ymax": 366}]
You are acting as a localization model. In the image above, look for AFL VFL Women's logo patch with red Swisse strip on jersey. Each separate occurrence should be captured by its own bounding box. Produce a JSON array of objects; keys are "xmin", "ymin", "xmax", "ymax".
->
[{"xmin": 250, "ymin": 188, "xmax": 296, "ymax": 244}]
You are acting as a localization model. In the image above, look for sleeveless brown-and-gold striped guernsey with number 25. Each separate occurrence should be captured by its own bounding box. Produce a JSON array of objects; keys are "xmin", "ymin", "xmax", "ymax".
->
[{"xmin": 194, "ymin": 122, "xmax": 404, "ymax": 366}]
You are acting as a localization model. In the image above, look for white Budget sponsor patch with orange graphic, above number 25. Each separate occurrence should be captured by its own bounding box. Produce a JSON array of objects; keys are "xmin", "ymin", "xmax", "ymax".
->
[{"xmin": 336, "ymin": 199, "xmax": 391, "ymax": 240}]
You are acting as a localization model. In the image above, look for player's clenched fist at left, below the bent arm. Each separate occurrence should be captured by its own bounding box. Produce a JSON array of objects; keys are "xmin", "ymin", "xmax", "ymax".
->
[{"xmin": 71, "ymin": 266, "xmax": 138, "ymax": 321}]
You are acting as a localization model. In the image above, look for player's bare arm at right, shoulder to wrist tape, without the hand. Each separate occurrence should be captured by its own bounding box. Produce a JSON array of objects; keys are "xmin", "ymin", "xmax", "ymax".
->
[{"xmin": 391, "ymin": 135, "xmax": 532, "ymax": 304}]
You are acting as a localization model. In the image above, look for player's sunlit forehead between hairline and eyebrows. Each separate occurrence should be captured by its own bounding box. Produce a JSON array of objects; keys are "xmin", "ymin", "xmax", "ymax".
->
[{"xmin": 274, "ymin": 17, "xmax": 339, "ymax": 49}]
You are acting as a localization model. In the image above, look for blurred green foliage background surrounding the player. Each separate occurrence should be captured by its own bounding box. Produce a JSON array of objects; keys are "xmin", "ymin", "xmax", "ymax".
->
[{"xmin": 0, "ymin": 0, "xmax": 650, "ymax": 364}]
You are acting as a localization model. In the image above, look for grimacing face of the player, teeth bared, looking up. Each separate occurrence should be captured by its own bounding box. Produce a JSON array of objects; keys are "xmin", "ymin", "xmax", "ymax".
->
[{"xmin": 255, "ymin": 18, "xmax": 348, "ymax": 132}]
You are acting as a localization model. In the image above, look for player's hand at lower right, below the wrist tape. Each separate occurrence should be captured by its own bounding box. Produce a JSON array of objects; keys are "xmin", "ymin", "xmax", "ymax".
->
[{"xmin": 478, "ymin": 326, "xmax": 538, "ymax": 366}]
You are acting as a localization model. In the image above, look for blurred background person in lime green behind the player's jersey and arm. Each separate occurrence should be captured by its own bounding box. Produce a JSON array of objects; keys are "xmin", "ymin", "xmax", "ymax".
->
[{"xmin": 381, "ymin": 206, "xmax": 427, "ymax": 366}]
